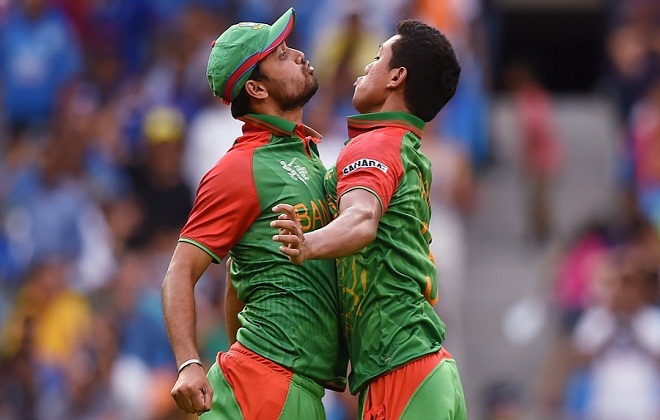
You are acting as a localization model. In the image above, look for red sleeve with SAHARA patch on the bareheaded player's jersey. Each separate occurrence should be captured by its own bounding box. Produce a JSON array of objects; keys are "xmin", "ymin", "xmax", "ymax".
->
[{"xmin": 336, "ymin": 130, "xmax": 404, "ymax": 213}]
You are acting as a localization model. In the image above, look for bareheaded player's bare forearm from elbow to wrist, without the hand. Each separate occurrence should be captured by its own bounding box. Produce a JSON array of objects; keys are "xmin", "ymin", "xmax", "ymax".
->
[{"xmin": 305, "ymin": 207, "xmax": 379, "ymax": 259}]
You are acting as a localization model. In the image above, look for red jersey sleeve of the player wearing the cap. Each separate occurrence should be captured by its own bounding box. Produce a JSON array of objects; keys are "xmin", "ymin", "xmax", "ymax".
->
[{"xmin": 179, "ymin": 149, "xmax": 260, "ymax": 263}]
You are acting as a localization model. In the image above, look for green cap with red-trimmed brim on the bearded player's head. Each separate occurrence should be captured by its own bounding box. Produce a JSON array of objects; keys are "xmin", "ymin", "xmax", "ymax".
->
[{"xmin": 206, "ymin": 8, "xmax": 296, "ymax": 104}]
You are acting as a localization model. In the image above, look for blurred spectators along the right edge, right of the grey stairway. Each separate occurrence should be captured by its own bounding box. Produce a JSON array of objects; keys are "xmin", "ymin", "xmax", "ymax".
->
[{"xmin": 532, "ymin": 0, "xmax": 660, "ymax": 420}]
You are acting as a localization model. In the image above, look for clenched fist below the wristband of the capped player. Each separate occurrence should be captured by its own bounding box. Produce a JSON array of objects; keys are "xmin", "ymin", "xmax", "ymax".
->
[{"xmin": 172, "ymin": 364, "xmax": 213, "ymax": 416}]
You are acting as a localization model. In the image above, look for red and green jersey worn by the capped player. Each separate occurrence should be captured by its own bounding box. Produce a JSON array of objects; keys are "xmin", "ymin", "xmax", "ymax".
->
[{"xmin": 179, "ymin": 114, "xmax": 346, "ymax": 387}]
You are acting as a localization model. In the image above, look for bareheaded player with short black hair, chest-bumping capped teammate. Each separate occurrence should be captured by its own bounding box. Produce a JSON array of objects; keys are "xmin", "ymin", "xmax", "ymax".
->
[{"xmin": 271, "ymin": 20, "xmax": 467, "ymax": 420}]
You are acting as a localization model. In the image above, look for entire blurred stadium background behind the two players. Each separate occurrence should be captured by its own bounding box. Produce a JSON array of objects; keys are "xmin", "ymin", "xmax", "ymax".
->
[{"xmin": 0, "ymin": 0, "xmax": 660, "ymax": 420}]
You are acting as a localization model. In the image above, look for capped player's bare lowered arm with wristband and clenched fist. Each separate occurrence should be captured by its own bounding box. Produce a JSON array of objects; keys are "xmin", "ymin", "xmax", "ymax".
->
[{"xmin": 162, "ymin": 242, "xmax": 213, "ymax": 415}]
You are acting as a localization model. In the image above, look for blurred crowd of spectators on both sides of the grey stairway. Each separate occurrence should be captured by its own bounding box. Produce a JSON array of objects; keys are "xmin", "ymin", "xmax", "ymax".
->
[{"xmin": 0, "ymin": 0, "xmax": 660, "ymax": 420}]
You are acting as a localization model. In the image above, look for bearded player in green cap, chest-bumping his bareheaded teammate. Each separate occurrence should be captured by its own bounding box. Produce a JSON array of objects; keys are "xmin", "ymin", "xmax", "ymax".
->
[{"xmin": 162, "ymin": 9, "xmax": 347, "ymax": 420}]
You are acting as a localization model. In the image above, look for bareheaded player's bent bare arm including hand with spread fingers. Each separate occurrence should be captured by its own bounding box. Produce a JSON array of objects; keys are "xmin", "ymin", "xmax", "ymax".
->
[{"xmin": 271, "ymin": 188, "xmax": 382, "ymax": 264}]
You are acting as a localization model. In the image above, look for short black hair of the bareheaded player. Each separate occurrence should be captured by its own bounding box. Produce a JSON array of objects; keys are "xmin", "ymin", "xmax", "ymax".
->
[{"xmin": 389, "ymin": 19, "xmax": 461, "ymax": 122}]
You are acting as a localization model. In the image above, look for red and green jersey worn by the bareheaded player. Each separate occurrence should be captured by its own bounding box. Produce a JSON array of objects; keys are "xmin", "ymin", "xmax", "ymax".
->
[{"xmin": 325, "ymin": 112, "xmax": 445, "ymax": 393}]
